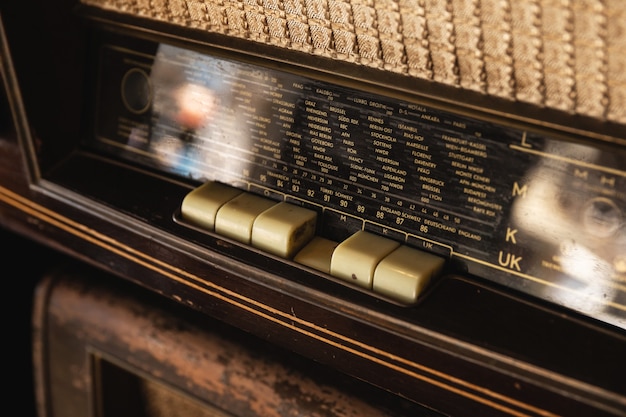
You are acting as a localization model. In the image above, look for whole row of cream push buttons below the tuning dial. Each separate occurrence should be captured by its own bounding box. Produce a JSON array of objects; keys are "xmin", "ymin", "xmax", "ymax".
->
[{"xmin": 181, "ymin": 182, "xmax": 444, "ymax": 304}]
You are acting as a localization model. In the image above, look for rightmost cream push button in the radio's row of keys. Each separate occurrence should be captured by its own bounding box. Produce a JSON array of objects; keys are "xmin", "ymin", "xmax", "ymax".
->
[{"xmin": 372, "ymin": 246, "xmax": 444, "ymax": 304}]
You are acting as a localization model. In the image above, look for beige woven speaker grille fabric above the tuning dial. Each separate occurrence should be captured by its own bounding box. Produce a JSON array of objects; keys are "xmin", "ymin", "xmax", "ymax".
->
[{"xmin": 82, "ymin": 0, "xmax": 626, "ymax": 123}]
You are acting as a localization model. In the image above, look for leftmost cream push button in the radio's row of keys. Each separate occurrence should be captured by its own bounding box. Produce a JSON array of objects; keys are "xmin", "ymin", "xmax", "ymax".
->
[{"xmin": 180, "ymin": 182, "xmax": 243, "ymax": 231}]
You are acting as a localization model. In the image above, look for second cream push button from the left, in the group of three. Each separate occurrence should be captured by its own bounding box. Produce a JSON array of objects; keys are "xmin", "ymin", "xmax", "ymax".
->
[{"xmin": 215, "ymin": 193, "xmax": 276, "ymax": 244}]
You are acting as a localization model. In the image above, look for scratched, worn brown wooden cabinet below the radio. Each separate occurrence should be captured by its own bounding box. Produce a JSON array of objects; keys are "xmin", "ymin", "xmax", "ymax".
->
[{"xmin": 35, "ymin": 268, "xmax": 438, "ymax": 417}]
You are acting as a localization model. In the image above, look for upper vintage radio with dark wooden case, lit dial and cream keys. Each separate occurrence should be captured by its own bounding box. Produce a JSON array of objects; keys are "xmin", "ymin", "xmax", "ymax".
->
[{"xmin": 1, "ymin": 0, "xmax": 626, "ymax": 416}]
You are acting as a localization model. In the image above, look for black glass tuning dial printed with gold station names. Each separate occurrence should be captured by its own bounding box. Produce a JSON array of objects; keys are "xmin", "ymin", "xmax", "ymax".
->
[{"xmin": 97, "ymin": 44, "xmax": 626, "ymax": 328}]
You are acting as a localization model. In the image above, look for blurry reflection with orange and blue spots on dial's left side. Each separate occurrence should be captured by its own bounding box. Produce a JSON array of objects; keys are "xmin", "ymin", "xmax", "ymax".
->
[{"xmin": 129, "ymin": 45, "xmax": 268, "ymax": 179}]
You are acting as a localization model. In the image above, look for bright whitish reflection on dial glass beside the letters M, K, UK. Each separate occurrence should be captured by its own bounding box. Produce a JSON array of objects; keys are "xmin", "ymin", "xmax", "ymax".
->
[{"xmin": 512, "ymin": 141, "xmax": 626, "ymax": 321}]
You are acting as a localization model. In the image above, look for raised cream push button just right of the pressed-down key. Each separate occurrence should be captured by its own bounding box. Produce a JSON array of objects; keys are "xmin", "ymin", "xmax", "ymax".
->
[{"xmin": 330, "ymin": 231, "xmax": 400, "ymax": 289}]
